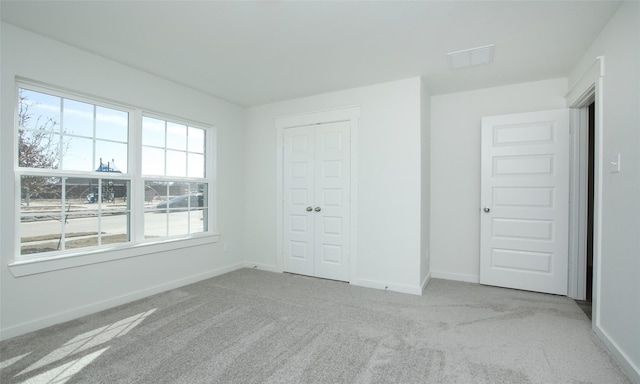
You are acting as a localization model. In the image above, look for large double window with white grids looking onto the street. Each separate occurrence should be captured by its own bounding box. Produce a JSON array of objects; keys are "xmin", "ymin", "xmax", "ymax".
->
[{"xmin": 16, "ymin": 84, "xmax": 210, "ymax": 259}]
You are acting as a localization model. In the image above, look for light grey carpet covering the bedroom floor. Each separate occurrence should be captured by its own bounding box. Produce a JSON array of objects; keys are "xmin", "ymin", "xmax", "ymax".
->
[{"xmin": 0, "ymin": 269, "xmax": 629, "ymax": 384}]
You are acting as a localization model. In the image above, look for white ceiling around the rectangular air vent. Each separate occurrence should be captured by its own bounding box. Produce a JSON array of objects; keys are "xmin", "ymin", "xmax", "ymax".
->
[{"xmin": 0, "ymin": 0, "xmax": 620, "ymax": 106}]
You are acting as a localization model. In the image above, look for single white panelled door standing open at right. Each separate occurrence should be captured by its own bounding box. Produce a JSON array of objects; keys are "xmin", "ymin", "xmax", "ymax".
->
[{"xmin": 480, "ymin": 109, "xmax": 569, "ymax": 295}]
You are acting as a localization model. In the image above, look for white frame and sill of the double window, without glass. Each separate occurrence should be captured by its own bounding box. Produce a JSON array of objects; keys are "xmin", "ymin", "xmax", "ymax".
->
[{"xmin": 9, "ymin": 79, "xmax": 220, "ymax": 277}]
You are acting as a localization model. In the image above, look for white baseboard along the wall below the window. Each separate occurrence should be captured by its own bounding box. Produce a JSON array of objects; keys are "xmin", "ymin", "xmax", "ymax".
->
[{"xmin": 0, "ymin": 263, "xmax": 245, "ymax": 340}]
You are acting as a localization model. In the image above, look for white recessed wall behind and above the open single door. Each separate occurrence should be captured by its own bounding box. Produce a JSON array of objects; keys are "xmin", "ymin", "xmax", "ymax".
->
[{"xmin": 431, "ymin": 79, "xmax": 567, "ymax": 282}]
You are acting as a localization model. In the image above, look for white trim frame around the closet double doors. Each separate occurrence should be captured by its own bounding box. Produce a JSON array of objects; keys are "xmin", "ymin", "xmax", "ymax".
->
[{"xmin": 275, "ymin": 106, "xmax": 360, "ymax": 282}]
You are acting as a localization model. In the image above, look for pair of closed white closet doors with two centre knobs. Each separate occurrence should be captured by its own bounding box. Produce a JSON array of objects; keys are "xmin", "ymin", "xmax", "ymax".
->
[{"xmin": 283, "ymin": 122, "xmax": 351, "ymax": 281}]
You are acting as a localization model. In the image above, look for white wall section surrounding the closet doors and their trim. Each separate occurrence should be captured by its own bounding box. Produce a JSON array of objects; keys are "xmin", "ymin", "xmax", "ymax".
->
[{"xmin": 245, "ymin": 78, "xmax": 422, "ymax": 293}]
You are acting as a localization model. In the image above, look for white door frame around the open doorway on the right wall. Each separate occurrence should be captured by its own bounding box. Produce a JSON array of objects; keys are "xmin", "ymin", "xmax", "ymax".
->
[{"xmin": 565, "ymin": 56, "xmax": 605, "ymax": 327}]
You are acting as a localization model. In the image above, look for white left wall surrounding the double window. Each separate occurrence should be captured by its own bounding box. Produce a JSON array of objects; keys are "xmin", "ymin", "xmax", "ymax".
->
[{"xmin": 0, "ymin": 23, "xmax": 244, "ymax": 338}]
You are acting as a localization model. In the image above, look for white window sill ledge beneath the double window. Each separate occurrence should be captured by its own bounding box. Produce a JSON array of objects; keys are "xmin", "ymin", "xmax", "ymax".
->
[{"xmin": 8, "ymin": 234, "xmax": 220, "ymax": 277}]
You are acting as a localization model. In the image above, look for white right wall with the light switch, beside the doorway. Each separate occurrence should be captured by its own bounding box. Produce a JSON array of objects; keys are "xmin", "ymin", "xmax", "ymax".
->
[{"xmin": 570, "ymin": 2, "xmax": 640, "ymax": 383}]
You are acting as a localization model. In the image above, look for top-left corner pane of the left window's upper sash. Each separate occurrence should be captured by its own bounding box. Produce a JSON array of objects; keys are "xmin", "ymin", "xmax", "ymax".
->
[{"xmin": 18, "ymin": 89, "xmax": 60, "ymax": 132}]
